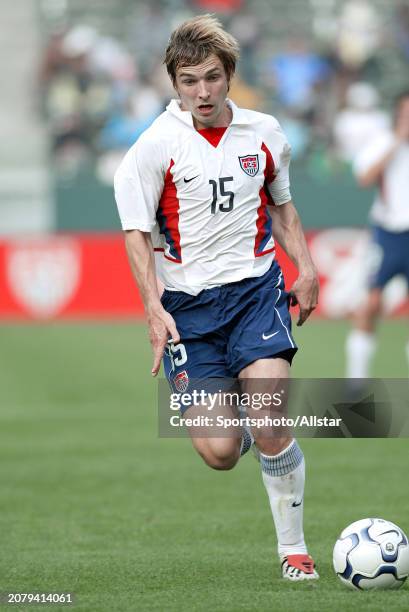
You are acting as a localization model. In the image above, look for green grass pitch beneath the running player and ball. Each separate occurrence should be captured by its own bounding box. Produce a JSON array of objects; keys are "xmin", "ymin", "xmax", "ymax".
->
[{"xmin": 0, "ymin": 321, "xmax": 409, "ymax": 612}]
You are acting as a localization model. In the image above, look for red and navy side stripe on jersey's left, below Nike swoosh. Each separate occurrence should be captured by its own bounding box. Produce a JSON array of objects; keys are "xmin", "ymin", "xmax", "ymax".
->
[{"xmin": 157, "ymin": 159, "xmax": 182, "ymax": 263}]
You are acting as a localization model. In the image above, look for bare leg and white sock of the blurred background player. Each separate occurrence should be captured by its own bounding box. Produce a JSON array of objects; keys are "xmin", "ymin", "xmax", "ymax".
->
[{"xmin": 346, "ymin": 287, "xmax": 382, "ymax": 378}]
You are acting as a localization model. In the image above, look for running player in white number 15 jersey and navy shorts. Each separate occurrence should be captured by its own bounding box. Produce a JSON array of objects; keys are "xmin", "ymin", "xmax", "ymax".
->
[{"xmin": 115, "ymin": 15, "xmax": 318, "ymax": 581}]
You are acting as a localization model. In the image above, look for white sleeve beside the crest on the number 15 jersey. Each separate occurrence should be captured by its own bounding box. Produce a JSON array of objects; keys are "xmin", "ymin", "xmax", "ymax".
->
[{"xmin": 265, "ymin": 120, "xmax": 291, "ymax": 206}]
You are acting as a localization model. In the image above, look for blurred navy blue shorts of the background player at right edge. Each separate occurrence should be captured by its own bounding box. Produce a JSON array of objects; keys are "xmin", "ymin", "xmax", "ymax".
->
[{"xmin": 369, "ymin": 227, "xmax": 409, "ymax": 289}]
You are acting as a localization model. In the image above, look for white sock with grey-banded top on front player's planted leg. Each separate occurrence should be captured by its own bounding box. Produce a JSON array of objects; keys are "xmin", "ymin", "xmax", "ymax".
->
[{"xmin": 260, "ymin": 440, "xmax": 307, "ymax": 559}]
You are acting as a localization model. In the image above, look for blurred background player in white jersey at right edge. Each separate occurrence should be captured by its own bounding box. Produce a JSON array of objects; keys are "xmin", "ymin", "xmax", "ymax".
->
[{"xmin": 346, "ymin": 90, "xmax": 409, "ymax": 378}]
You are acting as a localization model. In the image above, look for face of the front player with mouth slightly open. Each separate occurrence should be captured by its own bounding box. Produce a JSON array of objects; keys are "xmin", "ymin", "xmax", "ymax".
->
[{"xmin": 175, "ymin": 54, "xmax": 231, "ymax": 130}]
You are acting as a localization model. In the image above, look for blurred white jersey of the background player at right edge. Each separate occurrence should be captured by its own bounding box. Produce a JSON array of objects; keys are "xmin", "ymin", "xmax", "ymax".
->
[{"xmin": 354, "ymin": 131, "xmax": 409, "ymax": 232}]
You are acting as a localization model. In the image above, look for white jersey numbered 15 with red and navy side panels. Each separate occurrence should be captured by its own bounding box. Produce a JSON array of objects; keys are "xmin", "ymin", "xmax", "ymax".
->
[{"xmin": 115, "ymin": 100, "xmax": 291, "ymax": 295}]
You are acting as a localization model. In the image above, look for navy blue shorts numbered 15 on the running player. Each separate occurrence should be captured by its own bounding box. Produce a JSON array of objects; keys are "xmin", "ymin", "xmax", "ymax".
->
[{"xmin": 162, "ymin": 262, "xmax": 297, "ymax": 391}]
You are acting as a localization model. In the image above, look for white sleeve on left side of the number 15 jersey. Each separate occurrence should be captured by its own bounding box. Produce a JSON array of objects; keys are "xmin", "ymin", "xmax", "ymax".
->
[{"xmin": 114, "ymin": 133, "xmax": 164, "ymax": 232}]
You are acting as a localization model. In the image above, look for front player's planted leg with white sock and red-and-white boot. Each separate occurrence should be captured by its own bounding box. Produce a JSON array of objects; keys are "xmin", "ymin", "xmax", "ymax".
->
[{"xmin": 239, "ymin": 358, "xmax": 318, "ymax": 580}]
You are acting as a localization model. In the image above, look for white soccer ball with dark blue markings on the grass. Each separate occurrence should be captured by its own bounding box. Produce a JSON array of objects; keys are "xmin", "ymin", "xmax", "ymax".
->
[{"xmin": 333, "ymin": 518, "xmax": 409, "ymax": 590}]
